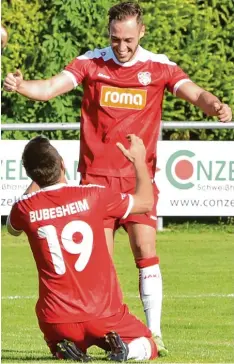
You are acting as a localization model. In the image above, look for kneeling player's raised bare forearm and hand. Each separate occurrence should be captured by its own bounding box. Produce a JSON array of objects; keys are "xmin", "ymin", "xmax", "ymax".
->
[{"xmin": 117, "ymin": 134, "xmax": 154, "ymax": 214}]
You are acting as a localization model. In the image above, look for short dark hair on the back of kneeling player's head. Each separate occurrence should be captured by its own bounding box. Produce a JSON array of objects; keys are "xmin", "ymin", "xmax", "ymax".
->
[{"xmin": 22, "ymin": 135, "xmax": 62, "ymax": 187}]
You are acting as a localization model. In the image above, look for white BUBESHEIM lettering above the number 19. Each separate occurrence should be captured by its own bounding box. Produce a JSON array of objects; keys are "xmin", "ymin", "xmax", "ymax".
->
[{"xmin": 29, "ymin": 199, "xmax": 89, "ymax": 222}]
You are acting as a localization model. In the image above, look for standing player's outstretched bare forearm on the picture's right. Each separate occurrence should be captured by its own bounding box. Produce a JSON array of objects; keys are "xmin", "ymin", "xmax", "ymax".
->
[{"xmin": 176, "ymin": 82, "xmax": 232, "ymax": 123}]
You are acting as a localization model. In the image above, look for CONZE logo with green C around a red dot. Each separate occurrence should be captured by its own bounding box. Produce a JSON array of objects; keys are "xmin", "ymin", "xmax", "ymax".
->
[{"xmin": 166, "ymin": 150, "xmax": 234, "ymax": 190}]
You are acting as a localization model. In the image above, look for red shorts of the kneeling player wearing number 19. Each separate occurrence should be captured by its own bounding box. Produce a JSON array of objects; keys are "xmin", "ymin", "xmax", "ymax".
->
[{"xmin": 39, "ymin": 305, "xmax": 157, "ymax": 355}]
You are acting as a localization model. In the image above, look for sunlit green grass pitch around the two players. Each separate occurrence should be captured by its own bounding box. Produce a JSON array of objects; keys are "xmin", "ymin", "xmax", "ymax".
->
[{"xmin": 2, "ymin": 224, "xmax": 234, "ymax": 363}]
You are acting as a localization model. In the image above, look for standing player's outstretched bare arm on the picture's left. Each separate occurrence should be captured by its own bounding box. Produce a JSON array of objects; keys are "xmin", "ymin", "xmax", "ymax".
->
[{"xmin": 3, "ymin": 70, "xmax": 74, "ymax": 101}]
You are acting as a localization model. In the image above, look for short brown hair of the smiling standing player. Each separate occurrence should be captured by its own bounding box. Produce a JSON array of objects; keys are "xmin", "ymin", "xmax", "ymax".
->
[{"xmin": 108, "ymin": 1, "xmax": 143, "ymax": 27}]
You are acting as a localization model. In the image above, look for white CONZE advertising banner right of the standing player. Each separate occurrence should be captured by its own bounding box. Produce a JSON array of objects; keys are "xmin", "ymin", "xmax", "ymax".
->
[{"xmin": 155, "ymin": 141, "xmax": 234, "ymax": 216}]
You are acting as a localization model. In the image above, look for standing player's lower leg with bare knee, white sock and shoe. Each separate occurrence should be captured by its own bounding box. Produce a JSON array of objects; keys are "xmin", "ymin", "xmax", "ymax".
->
[{"xmin": 126, "ymin": 222, "xmax": 167, "ymax": 356}]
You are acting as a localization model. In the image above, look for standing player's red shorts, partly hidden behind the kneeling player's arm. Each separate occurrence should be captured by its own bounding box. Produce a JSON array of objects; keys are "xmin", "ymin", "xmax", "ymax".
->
[{"xmin": 81, "ymin": 174, "xmax": 159, "ymax": 230}]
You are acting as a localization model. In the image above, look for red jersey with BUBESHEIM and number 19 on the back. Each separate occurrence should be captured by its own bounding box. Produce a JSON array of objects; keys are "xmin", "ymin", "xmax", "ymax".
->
[{"xmin": 8, "ymin": 184, "xmax": 133, "ymax": 323}]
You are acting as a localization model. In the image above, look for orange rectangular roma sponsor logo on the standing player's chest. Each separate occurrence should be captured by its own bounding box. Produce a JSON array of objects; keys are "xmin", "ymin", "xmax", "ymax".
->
[{"xmin": 100, "ymin": 86, "xmax": 147, "ymax": 110}]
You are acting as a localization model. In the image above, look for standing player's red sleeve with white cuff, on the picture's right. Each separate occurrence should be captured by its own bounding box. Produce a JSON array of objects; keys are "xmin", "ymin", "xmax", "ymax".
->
[{"xmin": 166, "ymin": 64, "xmax": 192, "ymax": 95}]
